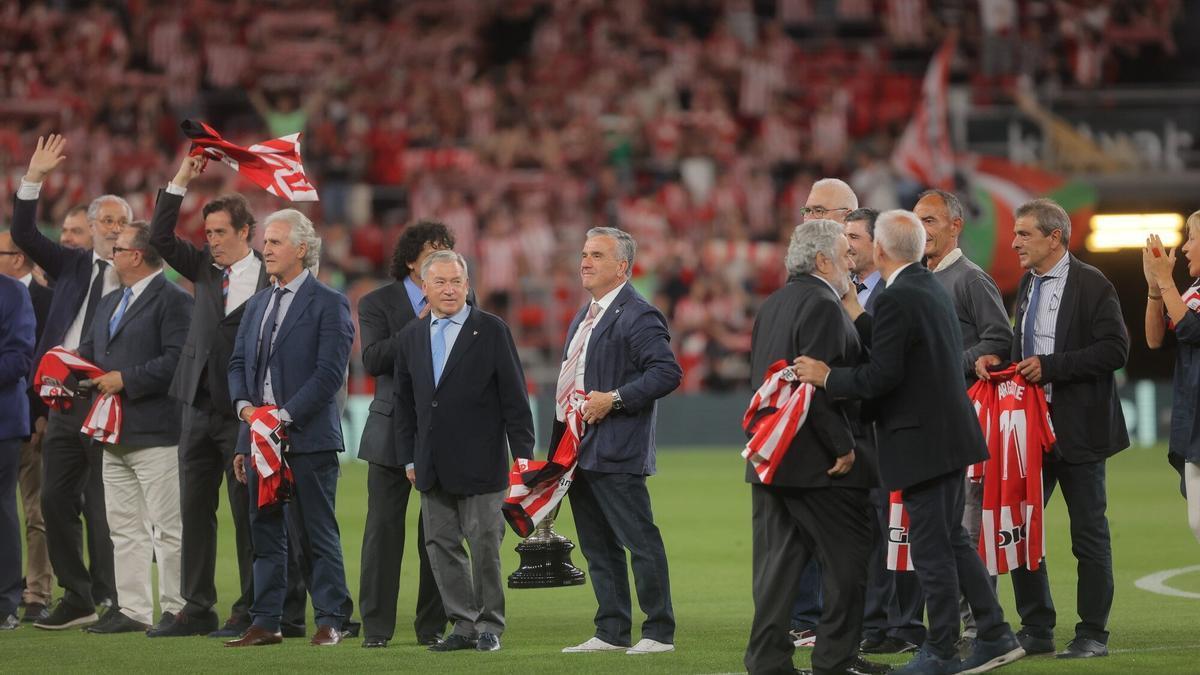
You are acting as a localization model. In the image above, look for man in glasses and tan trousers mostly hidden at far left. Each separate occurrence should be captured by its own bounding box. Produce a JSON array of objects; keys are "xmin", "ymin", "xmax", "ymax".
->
[{"xmin": 0, "ymin": 232, "xmax": 54, "ymax": 623}]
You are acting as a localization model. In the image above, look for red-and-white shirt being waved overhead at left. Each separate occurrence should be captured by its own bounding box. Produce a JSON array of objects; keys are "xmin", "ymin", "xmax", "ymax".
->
[{"xmin": 180, "ymin": 120, "xmax": 318, "ymax": 202}]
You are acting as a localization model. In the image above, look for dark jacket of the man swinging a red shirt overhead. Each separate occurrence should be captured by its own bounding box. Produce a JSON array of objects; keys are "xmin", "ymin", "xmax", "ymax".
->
[{"xmin": 150, "ymin": 190, "xmax": 270, "ymax": 416}]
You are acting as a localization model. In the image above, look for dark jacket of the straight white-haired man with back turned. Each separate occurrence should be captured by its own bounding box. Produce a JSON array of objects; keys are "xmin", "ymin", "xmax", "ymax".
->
[{"xmin": 826, "ymin": 264, "xmax": 988, "ymax": 490}]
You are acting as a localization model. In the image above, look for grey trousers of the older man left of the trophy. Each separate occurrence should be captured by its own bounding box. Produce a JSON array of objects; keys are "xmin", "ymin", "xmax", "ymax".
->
[{"xmin": 421, "ymin": 488, "xmax": 504, "ymax": 638}]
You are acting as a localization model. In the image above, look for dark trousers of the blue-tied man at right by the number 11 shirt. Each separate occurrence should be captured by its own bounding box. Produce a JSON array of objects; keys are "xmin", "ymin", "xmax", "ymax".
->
[{"xmin": 1009, "ymin": 456, "xmax": 1112, "ymax": 644}]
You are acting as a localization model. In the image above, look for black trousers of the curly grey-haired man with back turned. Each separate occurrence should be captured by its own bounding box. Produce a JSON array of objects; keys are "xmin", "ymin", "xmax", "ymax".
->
[{"xmin": 744, "ymin": 485, "xmax": 871, "ymax": 675}]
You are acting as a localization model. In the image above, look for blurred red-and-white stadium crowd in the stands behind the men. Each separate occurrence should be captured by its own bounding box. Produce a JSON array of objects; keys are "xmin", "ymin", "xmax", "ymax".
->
[{"xmin": 0, "ymin": 0, "xmax": 1180, "ymax": 392}]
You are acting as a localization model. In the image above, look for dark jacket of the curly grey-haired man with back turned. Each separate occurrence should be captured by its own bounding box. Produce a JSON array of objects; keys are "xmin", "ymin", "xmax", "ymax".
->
[{"xmin": 746, "ymin": 274, "xmax": 882, "ymax": 488}]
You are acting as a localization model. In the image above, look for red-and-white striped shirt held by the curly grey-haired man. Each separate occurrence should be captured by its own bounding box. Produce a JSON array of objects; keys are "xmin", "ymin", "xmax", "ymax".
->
[{"xmin": 742, "ymin": 359, "xmax": 815, "ymax": 485}]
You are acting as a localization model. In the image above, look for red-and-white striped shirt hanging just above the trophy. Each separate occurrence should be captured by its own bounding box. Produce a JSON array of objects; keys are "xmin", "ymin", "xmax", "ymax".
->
[{"xmin": 500, "ymin": 396, "xmax": 583, "ymax": 537}]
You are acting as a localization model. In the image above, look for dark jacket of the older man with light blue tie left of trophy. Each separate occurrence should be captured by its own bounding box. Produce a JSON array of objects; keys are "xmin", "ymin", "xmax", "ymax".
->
[{"xmin": 395, "ymin": 307, "xmax": 534, "ymax": 495}]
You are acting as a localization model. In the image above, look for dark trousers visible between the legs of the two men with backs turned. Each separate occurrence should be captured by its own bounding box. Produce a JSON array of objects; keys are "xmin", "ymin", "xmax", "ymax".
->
[{"xmin": 863, "ymin": 488, "xmax": 925, "ymax": 645}]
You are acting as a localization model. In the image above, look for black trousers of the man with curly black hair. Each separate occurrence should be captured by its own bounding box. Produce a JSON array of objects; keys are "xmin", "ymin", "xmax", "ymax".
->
[{"xmin": 359, "ymin": 462, "xmax": 446, "ymax": 640}]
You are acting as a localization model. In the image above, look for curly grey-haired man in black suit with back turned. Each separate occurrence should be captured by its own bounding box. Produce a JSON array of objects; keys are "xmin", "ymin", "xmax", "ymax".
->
[{"xmin": 745, "ymin": 220, "xmax": 887, "ymax": 673}]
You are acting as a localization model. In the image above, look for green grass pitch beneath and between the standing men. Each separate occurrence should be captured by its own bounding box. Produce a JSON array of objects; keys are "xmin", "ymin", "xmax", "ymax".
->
[{"xmin": 0, "ymin": 448, "xmax": 1200, "ymax": 674}]
